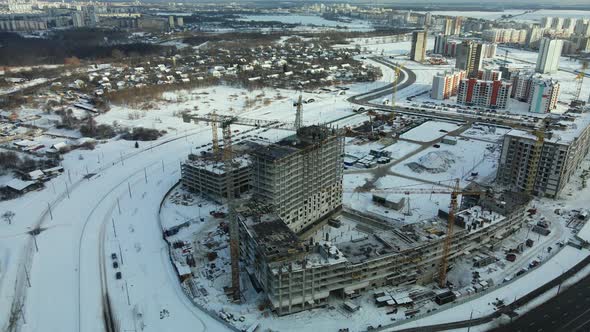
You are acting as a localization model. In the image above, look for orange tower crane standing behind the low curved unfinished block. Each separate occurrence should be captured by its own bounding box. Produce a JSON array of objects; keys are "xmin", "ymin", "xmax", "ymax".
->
[{"xmin": 344, "ymin": 179, "xmax": 486, "ymax": 287}]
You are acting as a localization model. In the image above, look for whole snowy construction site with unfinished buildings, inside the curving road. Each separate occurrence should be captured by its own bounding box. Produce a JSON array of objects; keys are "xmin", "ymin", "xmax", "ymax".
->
[{"xmin": 162, "ymin": 45, "xmax": 590, "ymax": 329}]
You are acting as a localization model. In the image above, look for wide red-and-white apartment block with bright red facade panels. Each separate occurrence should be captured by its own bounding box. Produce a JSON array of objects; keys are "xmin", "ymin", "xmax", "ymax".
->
[{"xmin": 457, "ymin": 78, "xmax": 512, "ymax": 109}]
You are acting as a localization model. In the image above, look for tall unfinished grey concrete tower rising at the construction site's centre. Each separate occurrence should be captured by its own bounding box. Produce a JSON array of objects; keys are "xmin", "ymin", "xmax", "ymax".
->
[{"xmin": 251, "ymin": 126, "xmax": 344, "ymax": 233}]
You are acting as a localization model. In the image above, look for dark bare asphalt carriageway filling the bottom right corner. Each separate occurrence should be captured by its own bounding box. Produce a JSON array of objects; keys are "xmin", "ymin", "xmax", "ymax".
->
[{"xmin": 492, "ymin": 276, "xmax": 590, "ymax": 332}]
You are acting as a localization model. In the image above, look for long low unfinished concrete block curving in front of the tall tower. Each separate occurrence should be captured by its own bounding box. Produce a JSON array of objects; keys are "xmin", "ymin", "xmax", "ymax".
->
[{"xmin": 240, "ymin": 196, "xmax": 525, "ymax": 315}]
